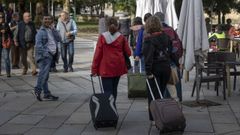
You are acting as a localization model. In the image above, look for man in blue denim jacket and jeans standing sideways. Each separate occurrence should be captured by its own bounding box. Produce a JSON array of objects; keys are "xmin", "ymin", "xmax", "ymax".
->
[{"xmin": 34, "ymin": 14, "xmax": 60, "ymax": 101}]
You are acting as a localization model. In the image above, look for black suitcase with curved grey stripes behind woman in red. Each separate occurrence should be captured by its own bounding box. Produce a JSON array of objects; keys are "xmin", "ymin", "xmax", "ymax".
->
[{"xmin": 89, "ymin": 76, "xmax": 119, "ymax": 129}]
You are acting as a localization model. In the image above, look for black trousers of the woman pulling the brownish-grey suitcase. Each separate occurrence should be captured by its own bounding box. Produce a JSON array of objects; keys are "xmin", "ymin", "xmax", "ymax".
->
[{"xmin": 147, "ymin": 64, "xmax": 171, "ymax": 121}]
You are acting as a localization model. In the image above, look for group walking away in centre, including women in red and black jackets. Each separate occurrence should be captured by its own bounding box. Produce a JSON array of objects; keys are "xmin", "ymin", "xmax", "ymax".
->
[{"xmin": 91, "ymin": 12, "xmax": 180, "ymax": 121}]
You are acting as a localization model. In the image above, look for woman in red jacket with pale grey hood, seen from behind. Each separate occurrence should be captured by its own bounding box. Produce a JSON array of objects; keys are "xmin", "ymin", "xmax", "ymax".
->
[{"xmin": 92, "ymin": 18, "xmax": 131, "ymax": 100}]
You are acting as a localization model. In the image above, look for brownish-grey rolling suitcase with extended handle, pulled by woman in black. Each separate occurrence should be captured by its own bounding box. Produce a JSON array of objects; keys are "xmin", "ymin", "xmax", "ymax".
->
[{"xmin": 146, "ymin": 78, "xmax": 186, "ymax": 133}]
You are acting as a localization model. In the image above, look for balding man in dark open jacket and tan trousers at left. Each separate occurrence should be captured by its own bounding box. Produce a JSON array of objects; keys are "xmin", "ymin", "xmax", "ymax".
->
[{"xmin": 14, "ymin": 12, "xmax": 38, "ymax": 76}]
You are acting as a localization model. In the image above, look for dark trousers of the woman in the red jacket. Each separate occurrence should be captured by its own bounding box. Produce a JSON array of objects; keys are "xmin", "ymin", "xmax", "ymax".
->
[{"xmin": 102, "ymin": 76, "xmax": 120, "ymax": 101}]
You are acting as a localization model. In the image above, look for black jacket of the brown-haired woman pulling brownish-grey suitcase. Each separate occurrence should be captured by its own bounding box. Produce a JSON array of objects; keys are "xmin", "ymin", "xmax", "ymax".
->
[{"xmin": 143, "ymin": 32, "xmax": 172, "ymax": 75}]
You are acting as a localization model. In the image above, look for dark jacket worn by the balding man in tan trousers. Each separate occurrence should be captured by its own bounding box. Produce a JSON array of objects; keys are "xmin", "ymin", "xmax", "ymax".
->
[{"xmin": 15, "ymin": 21, "xmax": 37, "ymax": 48}]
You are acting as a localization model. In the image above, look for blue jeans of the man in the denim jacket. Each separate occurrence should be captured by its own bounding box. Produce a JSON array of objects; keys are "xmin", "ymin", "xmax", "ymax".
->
[{"xmin": 35, "ymin": 56, "xmax": 52, "ymax": 95}]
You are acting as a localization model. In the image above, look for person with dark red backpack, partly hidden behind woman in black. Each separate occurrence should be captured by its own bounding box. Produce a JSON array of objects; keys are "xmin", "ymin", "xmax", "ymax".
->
[{"xmin": 154, "ymin": 12, "xmax": 183, "ymax": 101}]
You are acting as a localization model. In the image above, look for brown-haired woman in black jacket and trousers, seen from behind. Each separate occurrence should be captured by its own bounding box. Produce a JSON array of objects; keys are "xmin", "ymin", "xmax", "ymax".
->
[{"xmin": 143, "ymin": 16, "xmax": 172, "ymax": 124}]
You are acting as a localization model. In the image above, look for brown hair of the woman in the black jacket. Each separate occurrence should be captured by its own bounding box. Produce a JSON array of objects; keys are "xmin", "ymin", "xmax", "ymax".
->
[{"xmin": 144, "ymin": 16, "xmax": 162, "ymax": 34}]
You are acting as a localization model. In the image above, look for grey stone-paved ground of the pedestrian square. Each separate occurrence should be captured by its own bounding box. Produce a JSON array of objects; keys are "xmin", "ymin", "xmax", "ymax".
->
[{"xmin": 0, "ymin": 37, "xmax": 240, "ymax": 135}]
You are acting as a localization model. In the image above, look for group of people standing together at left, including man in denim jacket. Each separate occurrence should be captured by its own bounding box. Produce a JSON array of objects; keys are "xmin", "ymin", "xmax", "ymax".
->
[{"xmin": 0, "ymin": 8, "xmax": 77, "ymax": 101}]
